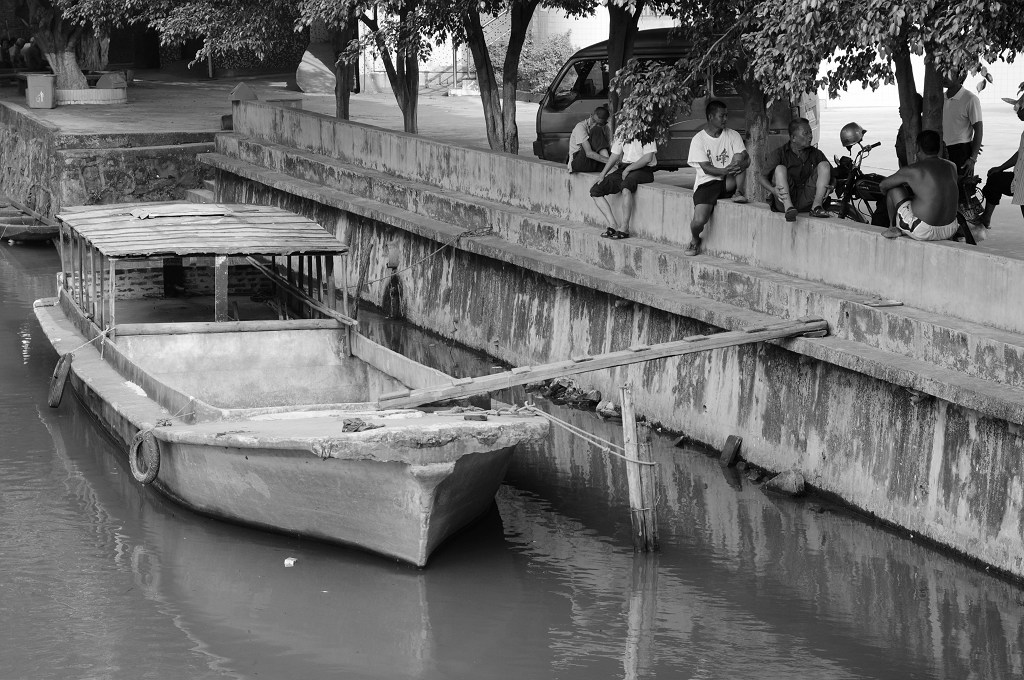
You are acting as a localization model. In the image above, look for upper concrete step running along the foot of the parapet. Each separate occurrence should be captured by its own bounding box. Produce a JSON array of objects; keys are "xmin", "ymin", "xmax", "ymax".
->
[{"xmin": 211, "ymin": 135, "xmax": 1024, "ymax": 387}]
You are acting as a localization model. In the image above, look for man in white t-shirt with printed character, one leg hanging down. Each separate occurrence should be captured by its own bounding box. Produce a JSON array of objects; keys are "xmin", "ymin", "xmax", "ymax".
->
[{"xmin": 686, "ymin": 99, "xmax": 751, "ymax": 255}]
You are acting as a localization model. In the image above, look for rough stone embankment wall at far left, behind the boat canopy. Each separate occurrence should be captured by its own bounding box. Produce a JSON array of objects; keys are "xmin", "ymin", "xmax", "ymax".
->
[{"xmin": 0, "ymin": 101, "xmax": 213, "ymax": 217}]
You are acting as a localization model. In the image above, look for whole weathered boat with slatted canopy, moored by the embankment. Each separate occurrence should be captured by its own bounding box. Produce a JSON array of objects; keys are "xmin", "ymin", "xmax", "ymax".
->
[{"xmin": 35, "ymin": 203, "xmax": 547, "ymax": 566}]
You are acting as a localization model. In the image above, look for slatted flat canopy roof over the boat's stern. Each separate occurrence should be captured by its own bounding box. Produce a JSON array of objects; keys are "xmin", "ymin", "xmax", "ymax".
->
[{"xmin": 57, "ymin": 201, "xmax": 348, "ymax": 257}]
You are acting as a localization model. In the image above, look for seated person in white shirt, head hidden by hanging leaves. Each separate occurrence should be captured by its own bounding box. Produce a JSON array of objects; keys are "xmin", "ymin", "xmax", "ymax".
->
[{"xmin": 590, "ymin": 135, "xmax": 657, "ymax": 239}]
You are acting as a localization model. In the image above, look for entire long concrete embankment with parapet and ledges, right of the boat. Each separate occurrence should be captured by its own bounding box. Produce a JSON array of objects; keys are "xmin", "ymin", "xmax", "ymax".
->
[{"xmin": 207, "ymin": 103, "xmax": 1024, "ymax": 577}]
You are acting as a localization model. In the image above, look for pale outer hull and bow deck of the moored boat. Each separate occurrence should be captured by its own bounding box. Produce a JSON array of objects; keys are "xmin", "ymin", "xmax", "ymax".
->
[{"xmin": 36, "ymin": 301, "xmax": 547, "ymax": 566}]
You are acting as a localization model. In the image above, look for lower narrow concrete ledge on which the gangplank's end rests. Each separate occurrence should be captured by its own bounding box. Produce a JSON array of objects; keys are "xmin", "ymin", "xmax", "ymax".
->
[{"xmin": 206, "ymin": 148, "xmax": 1024, "ymax": 424}]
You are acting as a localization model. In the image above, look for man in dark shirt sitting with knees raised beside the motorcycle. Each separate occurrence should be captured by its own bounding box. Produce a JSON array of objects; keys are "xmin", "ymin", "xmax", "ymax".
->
[{"xmin": 758, "ymin": 118, "xmax": 831, "ymax": 222}]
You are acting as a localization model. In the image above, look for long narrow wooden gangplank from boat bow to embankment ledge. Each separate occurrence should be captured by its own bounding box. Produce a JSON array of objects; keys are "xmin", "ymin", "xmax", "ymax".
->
[{"xmin": 381, "ymin": 318, "xmax": 828, "ymax": 409}]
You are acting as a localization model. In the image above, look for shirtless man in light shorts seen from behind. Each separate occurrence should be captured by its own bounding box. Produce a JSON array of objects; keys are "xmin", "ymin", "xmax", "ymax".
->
[{"xmin": 879, "ymin": 130, "xmax": 957, "ymax": 241}]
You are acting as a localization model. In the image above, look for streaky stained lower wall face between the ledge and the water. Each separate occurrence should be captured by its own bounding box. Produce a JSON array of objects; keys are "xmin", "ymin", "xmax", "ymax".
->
[{"xmin": 218, "ymin": 178, "xmax": 1024, "ymax": 577}]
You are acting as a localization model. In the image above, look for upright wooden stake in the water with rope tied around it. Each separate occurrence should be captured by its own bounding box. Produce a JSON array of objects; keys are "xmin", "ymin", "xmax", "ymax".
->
[{"xmin": 621, "ymin": 385, "xmax": 657, "ymax": 552}]
